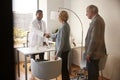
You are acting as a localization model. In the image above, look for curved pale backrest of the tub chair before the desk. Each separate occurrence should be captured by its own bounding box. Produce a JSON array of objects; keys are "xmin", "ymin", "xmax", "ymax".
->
[{"xmin": 31, "ymin": 58, "xmax": 62, "ymax": 80}]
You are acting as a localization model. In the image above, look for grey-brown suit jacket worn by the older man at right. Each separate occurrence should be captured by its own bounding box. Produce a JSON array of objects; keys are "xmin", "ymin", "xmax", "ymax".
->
[{"xmin": 85, "ymin": 15, "xmax": 106, "ymax": 59}]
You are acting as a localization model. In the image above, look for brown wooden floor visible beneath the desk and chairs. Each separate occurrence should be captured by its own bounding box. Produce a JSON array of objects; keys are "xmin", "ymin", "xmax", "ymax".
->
[{"xmin": 16, "ymin": 62, "xmax": 108, "ymax": 80}]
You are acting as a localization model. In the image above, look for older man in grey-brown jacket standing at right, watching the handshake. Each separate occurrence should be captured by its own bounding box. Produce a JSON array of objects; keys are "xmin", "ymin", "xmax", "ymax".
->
[{"xmin": 85, "ymin": 5, "xmax": 106, "ymax": 80}]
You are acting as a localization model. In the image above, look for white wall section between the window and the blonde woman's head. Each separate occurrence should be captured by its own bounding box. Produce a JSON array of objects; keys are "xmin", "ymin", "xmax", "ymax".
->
[{"xmin": 47, "ymin": 0, "xmax": 64, "ymax": 32}]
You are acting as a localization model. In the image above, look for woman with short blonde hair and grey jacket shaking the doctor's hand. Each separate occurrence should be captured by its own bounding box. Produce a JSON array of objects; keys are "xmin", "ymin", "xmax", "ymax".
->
[{"xmin": 49, "ymin": 11, "xmax": 71, "ymax": 80}]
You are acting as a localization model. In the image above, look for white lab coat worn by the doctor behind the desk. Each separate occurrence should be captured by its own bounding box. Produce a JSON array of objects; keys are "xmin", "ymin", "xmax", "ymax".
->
[{"xmin": 29, "ymin": 19, "xmax": 47, "ymax": 47}]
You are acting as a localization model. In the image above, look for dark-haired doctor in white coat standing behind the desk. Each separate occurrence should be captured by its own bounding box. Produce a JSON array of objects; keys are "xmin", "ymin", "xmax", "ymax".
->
[{"xmin": 30, "ymin": 10, "xmax": 47, "ymax": 61}]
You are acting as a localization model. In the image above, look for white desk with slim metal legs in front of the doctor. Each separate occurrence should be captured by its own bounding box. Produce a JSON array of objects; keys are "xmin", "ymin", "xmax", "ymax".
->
[{"xmin": 17, "ymin": 46, "xmax": 80, "ymax": 80}]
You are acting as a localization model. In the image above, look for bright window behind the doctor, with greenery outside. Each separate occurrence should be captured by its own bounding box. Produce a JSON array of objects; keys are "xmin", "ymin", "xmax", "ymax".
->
[{"xmin": 13, "ymin": 0, "xmax": 37, "ymax": 47}]
